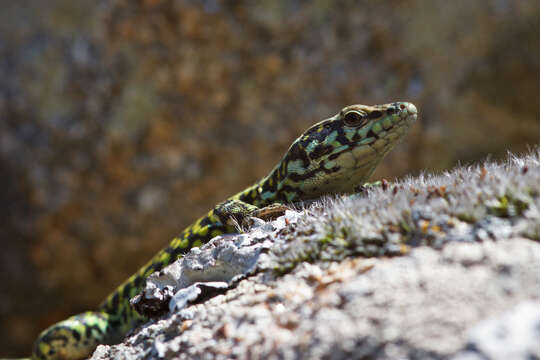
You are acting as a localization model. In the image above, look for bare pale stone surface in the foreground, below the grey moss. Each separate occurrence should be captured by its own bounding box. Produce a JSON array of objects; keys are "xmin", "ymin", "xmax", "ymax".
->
[{"xmin": 92, "ymin": 238, "xmax": 540, "ymax": 360}]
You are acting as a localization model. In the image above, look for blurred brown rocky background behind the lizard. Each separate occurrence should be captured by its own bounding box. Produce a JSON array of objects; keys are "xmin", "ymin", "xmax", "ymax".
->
[{"xmin": 0, "ymin": 0, "xmax": 540, "ymax": 356}]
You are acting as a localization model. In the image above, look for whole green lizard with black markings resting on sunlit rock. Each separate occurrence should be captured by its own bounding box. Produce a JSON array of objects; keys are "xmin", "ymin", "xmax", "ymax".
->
[{"xmin": 32, "ymin": 102, "xmax": 417, "ymax": 359}]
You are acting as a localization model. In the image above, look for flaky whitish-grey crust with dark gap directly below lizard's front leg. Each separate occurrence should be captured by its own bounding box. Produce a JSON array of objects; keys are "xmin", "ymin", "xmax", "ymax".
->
[{"xmin": 130, "ymin": 210, "xmax": 302, "ymax": 317}]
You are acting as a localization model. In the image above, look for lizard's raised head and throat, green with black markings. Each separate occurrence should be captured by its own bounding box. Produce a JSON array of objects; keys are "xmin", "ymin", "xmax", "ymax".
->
[{"xmin": 270, "ymin": 102, "xmax": 417, "ymax": 202}]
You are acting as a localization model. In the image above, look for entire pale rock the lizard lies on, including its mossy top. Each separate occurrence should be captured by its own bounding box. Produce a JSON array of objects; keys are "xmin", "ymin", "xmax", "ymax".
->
[{"xmin": 93, "ymin": 153, "xmax": 540, "ymax": 360}]
